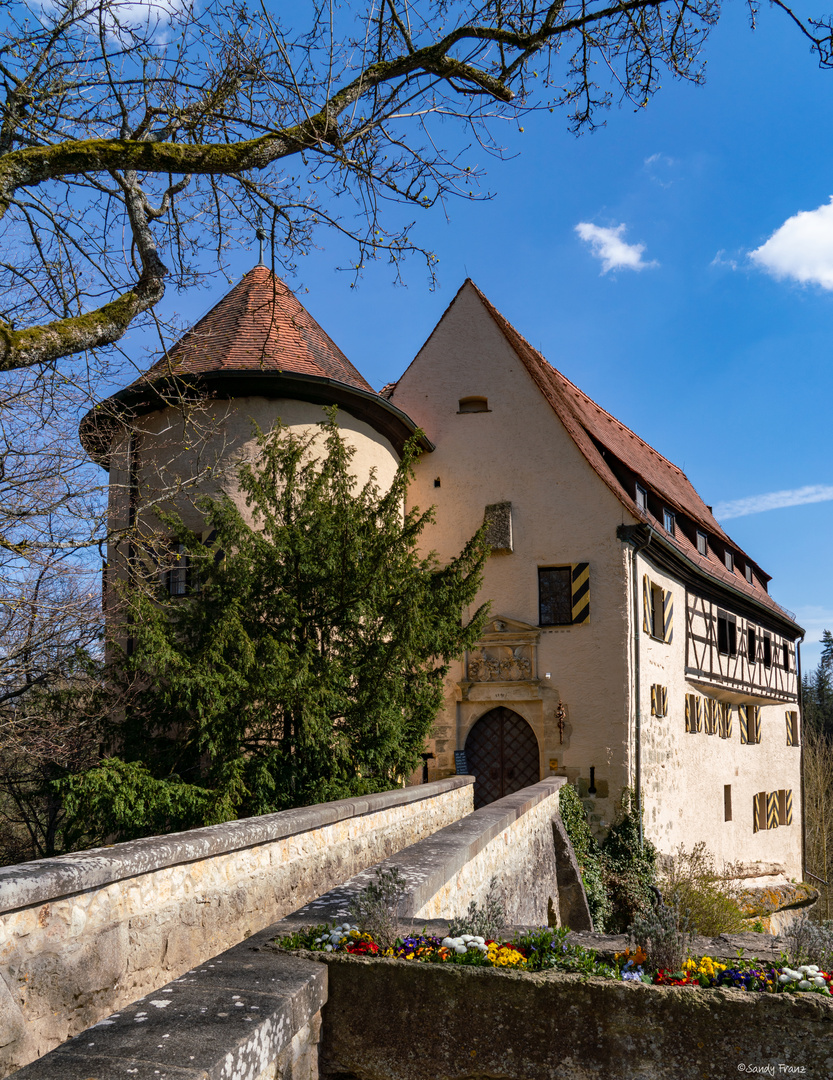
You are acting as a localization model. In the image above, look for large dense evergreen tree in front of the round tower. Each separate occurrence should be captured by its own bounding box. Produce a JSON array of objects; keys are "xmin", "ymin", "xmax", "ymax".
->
[{"xmin": 62, "ymin": 413, "xmax": 486, "ymax": 839}]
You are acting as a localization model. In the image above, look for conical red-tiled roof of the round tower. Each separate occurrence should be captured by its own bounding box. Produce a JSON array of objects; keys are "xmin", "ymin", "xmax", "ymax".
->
[{"xmin": 140, "ymin": 266, "xmax": 375, "ymax": 393}]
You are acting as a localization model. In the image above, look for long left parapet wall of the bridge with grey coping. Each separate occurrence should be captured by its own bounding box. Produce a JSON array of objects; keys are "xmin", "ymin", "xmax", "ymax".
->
[{"xmin": 0, "ymin": 777, "xmax": 472, "ymax": 1076}]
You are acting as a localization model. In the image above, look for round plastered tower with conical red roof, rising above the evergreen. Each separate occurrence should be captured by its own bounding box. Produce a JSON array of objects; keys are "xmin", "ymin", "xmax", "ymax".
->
[{"xmin": 80, "ymin": 266, "xmax": 432, "ymax": 587}]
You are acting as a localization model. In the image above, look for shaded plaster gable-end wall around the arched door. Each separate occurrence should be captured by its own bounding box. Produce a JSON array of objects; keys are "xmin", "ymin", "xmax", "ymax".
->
[{"xmin": 392, "ymin": 287, "xmax": 629, "ymax": 819}]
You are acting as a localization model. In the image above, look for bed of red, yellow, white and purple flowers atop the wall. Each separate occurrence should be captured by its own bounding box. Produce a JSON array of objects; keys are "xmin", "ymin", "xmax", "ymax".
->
[{"xmin": 279, "ymin": 922, "xmax": 833, "ymax": 997}]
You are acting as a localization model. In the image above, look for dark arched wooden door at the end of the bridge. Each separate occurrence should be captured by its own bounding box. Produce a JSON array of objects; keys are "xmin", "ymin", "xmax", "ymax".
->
[{"xmin": 466, "ymin": 707, "xmax": 540, "ymax": 810}]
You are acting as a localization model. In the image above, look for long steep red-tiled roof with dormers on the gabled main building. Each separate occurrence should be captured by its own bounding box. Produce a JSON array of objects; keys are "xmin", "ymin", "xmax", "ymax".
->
[{"xmin": 393, "ymin": 279, "xmax": 794, "ymax": 624}]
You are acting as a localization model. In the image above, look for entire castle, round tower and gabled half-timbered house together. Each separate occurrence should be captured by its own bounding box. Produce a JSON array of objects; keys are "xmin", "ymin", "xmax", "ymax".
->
[{"xmin": 81, "ymin": 266, "xmax": 803, "ymax": 879}]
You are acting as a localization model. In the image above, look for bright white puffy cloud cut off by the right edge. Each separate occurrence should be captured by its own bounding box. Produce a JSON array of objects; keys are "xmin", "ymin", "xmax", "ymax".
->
[{"xmin": 750, "ymin": 197, "xmax": 833, "ymax": 289}]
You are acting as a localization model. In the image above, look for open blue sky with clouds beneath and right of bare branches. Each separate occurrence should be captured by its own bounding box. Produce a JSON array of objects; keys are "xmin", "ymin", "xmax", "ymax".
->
[{"xmin": 136, "ymin": 3, "xmax": 833, "ymax": 670}]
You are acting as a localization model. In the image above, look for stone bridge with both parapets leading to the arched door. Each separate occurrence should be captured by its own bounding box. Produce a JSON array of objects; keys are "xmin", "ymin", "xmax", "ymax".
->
[{"xmin": 0, "ymin": 777, "xmax": 591, "ymax": 1076}]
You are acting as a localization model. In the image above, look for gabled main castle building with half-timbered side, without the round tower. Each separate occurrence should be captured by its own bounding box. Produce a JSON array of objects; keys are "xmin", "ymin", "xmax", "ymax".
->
[{"xmin": 384, "ymin": 282, "xmax": 802, "ymax": 880}]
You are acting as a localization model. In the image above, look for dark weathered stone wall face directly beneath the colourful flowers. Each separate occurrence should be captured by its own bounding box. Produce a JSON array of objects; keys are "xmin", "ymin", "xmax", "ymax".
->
[{"xmin": 317, "ymin": 953, "xmax": 833, "ymax": 1080}]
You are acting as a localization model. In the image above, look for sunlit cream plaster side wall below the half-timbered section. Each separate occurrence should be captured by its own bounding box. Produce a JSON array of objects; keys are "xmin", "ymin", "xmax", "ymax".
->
[{"xmin": 636, "ymin": 554, "xmax": 802, "ymax": 880}]
